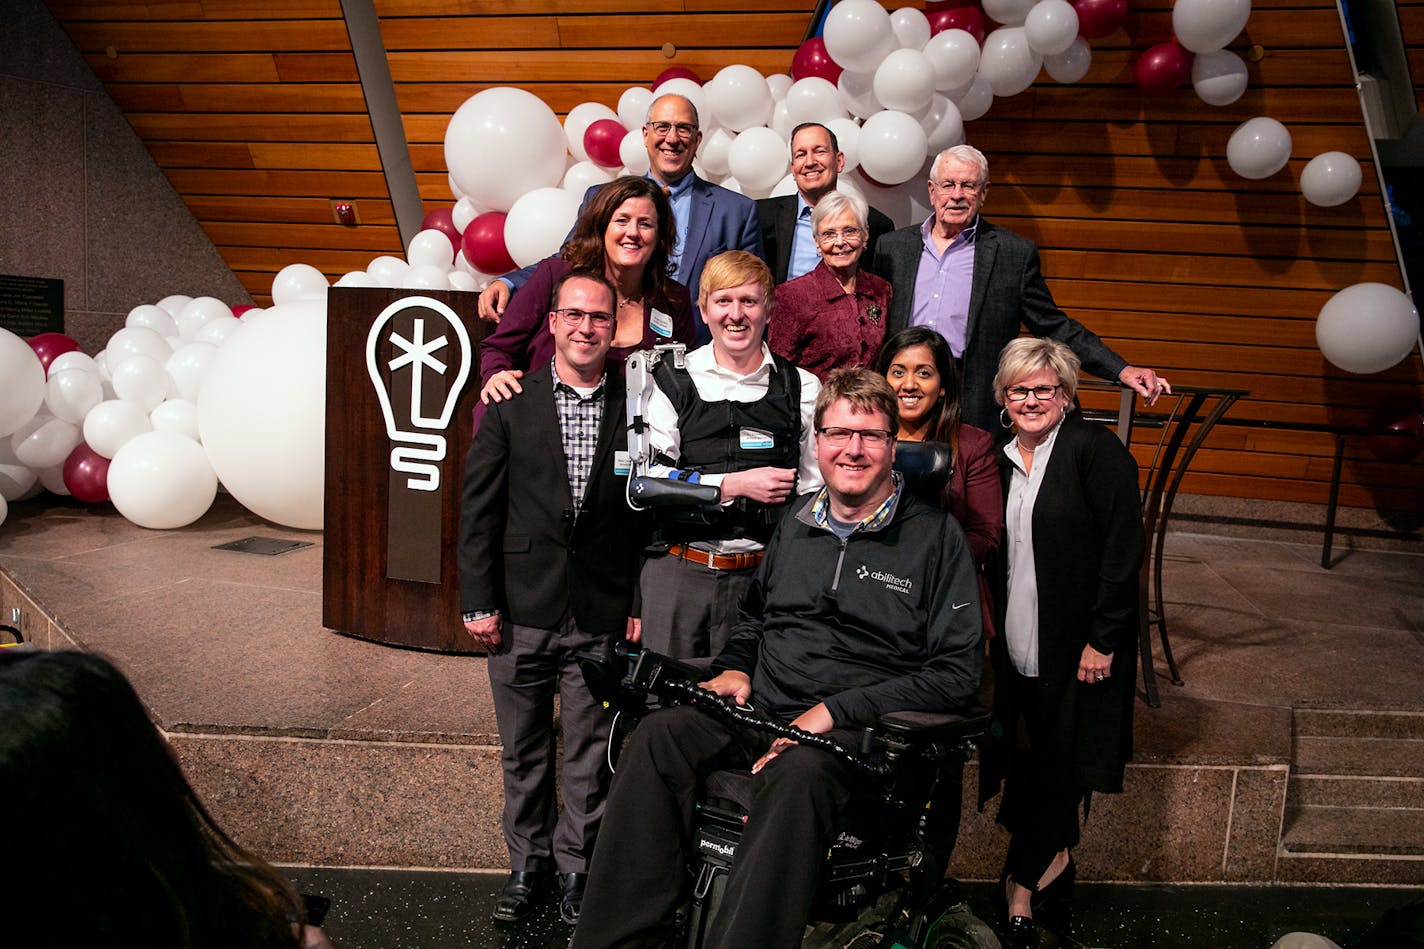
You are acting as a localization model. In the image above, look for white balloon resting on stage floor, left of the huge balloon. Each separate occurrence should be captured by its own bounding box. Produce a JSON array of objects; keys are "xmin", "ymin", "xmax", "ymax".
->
[{"xmin": 108, "ymin": 432, "xmax": 218, "ymax": 530}]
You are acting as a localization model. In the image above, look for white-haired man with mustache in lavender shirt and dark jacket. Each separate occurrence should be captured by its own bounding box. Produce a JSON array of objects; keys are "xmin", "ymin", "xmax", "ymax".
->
[{"xmin": 869, "ymin": 145, "xmax": 1172, "ymax": 432}]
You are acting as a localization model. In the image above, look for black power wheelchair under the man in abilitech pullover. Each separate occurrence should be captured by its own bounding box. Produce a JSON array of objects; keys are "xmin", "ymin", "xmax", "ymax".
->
[{"xmin": 582, "ymin": 641, "xmax": 1000, "ymax": 949}]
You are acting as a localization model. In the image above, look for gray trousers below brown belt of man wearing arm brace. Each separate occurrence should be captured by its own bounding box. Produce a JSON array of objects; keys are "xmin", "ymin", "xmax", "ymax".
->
[{"xmin": 639, "ymin": 554, "xmax": 756, "ymax": 660}]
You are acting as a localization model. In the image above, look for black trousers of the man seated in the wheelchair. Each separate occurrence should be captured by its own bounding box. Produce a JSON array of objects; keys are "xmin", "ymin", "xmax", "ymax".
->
[{"xmin": 572, "ymin": 707, "xmax": 856, "ymax": 949}]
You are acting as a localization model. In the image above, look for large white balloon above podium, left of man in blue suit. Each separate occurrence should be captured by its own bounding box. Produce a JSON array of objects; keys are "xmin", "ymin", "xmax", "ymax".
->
[{"xmin": 449, "ymin": 85, "xmax": 567, "ymax": 210}]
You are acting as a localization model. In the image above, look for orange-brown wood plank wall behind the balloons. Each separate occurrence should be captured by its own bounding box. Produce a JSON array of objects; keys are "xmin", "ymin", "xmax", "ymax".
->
[{"xmin": 48, "ymin": 0, "xmax": 1424, "ymax": 510}]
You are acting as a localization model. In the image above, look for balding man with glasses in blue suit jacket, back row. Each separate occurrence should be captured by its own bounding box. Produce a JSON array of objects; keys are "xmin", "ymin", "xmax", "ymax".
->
[{"xmin": 480, "ymin": 94, "xmax": 766, "ymax": 346}]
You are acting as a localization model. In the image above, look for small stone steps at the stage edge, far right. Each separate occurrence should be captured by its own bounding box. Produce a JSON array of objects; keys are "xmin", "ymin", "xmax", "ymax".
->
[{"xmin": 1276, "ymin": 708, "xmax": 1424, "ymax": 885}]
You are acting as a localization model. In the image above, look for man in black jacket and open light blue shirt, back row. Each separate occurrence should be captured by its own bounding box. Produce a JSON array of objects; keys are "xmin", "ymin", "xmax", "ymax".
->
[{"xmin": 756, "ymin": 123, "xmax": 894, "ymax": 284}]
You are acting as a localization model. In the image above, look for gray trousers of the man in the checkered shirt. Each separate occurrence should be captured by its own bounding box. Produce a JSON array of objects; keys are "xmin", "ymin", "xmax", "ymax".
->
[{"xmin": 488, "ymin": 616, "xmax": 612, "ymax": 873}]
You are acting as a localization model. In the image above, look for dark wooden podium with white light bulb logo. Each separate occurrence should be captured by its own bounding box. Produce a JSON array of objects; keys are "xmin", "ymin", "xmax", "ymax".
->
[{"xmin": 322, "ymin": 286, "xmax": 484, "ymax": 653}]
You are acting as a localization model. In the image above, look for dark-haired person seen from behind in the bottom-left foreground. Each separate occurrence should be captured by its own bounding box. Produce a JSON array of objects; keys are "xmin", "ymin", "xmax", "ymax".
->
[{"xmin": 0, "ymin": 650, "xmax": 332, "ymax": 949}]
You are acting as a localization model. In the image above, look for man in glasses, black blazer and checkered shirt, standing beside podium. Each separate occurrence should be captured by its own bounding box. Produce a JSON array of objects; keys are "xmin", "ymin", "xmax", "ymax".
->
[{"xmin": 460, "ymin": 266, "xmax": 641, "ymax": 922}]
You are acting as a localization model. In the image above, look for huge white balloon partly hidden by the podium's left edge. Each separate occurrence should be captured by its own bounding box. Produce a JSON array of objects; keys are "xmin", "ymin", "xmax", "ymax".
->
[{"xmin": 199, "ymin": 301, "xmax": 326, "ymax": 530}]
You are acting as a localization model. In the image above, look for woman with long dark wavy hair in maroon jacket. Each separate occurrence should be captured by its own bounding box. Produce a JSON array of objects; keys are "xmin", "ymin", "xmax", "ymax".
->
[{"xmin": 480, "ymin": 177, "xmax": 696, "ymax": 403}]
